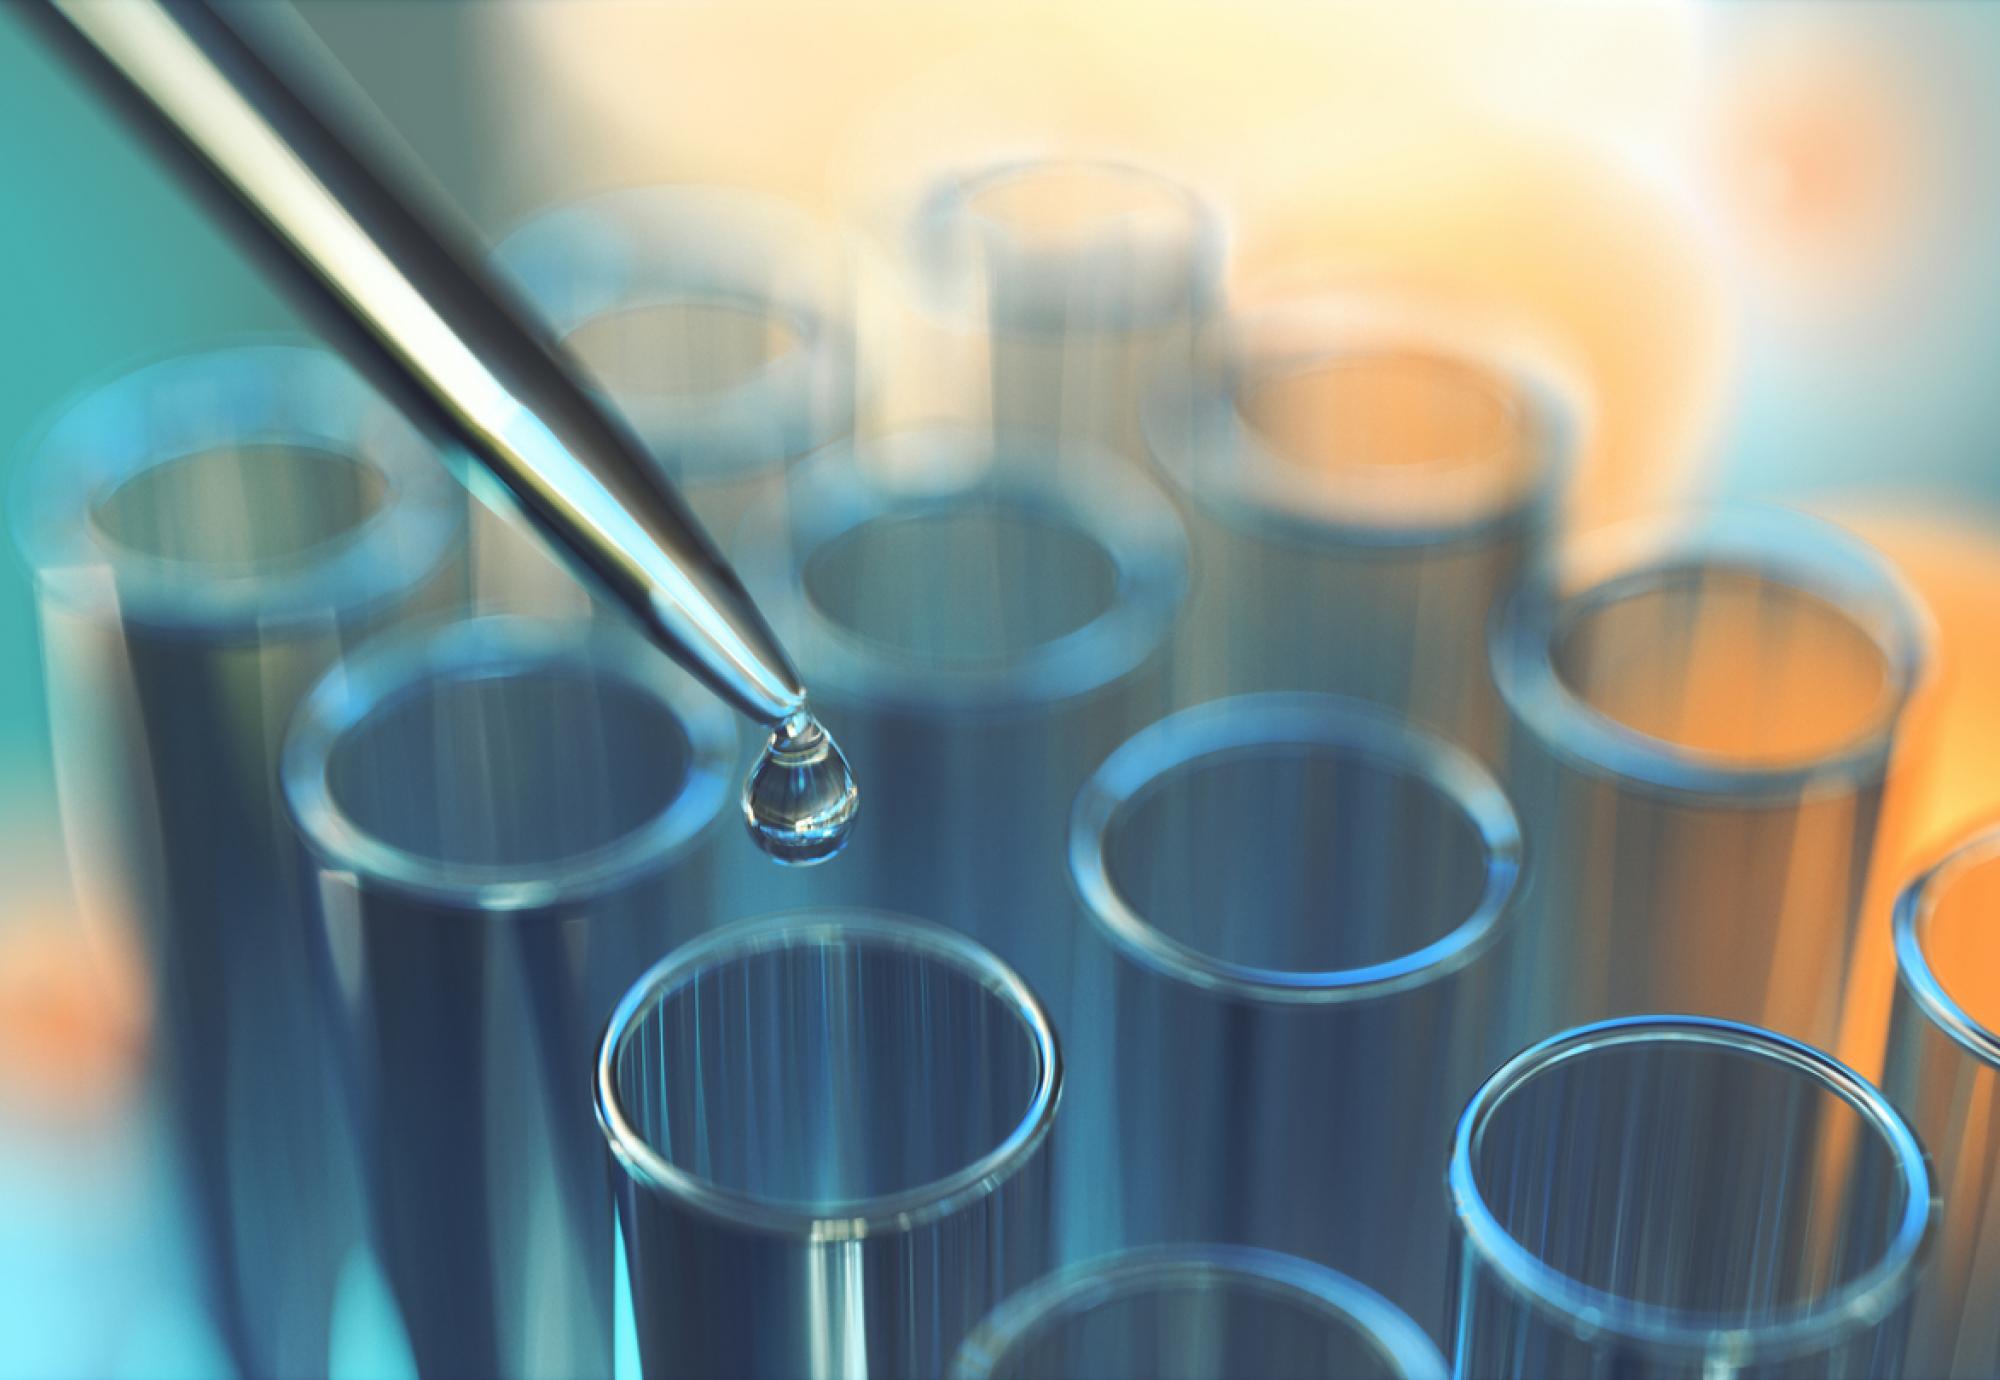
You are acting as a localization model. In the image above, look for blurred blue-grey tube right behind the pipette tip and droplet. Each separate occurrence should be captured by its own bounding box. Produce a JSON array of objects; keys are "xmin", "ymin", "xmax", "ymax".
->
[{"xmin": 736, "ymin": 428, "xmax": 1186, "ymax": 1020}]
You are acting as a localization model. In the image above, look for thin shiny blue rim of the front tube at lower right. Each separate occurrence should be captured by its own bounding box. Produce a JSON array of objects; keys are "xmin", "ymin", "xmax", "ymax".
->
[{"xmin": 1446, "ymin": 1016, "xmax": 1936, "ymax": 1364}]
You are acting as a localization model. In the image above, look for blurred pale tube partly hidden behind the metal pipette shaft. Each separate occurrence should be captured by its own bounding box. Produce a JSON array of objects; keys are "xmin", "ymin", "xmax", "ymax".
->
[{"xmin": 492, "ymin": 186, "xmax": 856, "ymax": 608}]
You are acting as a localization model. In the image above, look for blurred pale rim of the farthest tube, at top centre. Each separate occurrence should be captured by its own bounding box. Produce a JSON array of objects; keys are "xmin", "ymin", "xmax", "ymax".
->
[{"xmin": 908, "ymin": 154, "xmax": 1228, "ymax": 334}]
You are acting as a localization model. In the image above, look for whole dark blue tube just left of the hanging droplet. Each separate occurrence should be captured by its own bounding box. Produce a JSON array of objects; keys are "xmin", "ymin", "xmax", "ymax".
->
[{"xmin": 284, "ymin": 618, "xmax": 734, "ymax": 1380}]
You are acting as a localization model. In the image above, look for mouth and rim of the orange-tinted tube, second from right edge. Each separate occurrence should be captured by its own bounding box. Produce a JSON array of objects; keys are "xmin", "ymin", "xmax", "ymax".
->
[{"xmin": 1492, "ymin": 510, "xmax": 1924, "ymax": 792}]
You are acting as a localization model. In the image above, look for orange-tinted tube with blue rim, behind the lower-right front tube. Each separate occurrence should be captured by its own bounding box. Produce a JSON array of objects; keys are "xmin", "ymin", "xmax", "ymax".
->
[{"xmin": 1492, "ymin": 508, "xmax": 1926, "ymax": 1046}]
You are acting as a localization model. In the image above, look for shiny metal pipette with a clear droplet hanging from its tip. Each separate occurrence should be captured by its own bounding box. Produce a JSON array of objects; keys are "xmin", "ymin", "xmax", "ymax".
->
[{"xmin": 26, "ymin": 0, "xmax": 860, "ymax": 864}]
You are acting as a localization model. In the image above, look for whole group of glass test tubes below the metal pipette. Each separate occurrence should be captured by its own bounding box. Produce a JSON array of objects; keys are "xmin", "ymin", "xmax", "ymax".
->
[{"xmin": 14, "ymin": 156, "xmax": 2000, "ymax": 1380}]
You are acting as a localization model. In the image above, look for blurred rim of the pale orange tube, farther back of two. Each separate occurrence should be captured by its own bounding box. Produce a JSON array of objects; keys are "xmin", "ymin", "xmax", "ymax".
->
[{"xmin": 1140, "ymin": 298, "xmax": 1578, "ymax": 554}]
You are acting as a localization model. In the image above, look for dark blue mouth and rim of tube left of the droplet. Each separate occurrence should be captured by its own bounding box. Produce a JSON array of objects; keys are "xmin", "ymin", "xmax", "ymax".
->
[{"xmin": 286, "ymin": 618, "xmax": 732, "ymax": 902}]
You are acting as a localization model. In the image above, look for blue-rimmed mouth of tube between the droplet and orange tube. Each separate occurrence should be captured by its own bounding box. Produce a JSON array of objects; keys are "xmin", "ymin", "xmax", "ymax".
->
[{"xmin": 1072, "ymin": 694, "xmax": 1520, "ymax": 1000}]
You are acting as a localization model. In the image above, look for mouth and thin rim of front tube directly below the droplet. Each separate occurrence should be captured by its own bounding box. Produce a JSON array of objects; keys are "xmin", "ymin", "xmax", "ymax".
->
[{"xmin": 598, "ymin": 912, "xmax": 1062, "ymax": 1240}]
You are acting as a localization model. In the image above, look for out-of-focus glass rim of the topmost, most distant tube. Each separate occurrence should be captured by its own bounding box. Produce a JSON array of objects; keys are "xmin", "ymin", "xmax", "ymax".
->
[{"xmin": 904, "ymin": 150, "xmax": 1228, "ymax": 340}]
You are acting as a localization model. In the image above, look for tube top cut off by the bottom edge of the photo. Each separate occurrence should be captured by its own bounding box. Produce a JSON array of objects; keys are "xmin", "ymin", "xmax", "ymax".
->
[{"xmin": 948, "ymin": 1246, "xmax": 1444, "ymax": 1380}]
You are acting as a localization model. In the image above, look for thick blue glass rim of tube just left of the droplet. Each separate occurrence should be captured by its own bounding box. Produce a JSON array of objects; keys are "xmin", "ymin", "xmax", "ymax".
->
[{"xmin": 280, "ymin": 614, "xmax": 736, "ymax": 914}]
